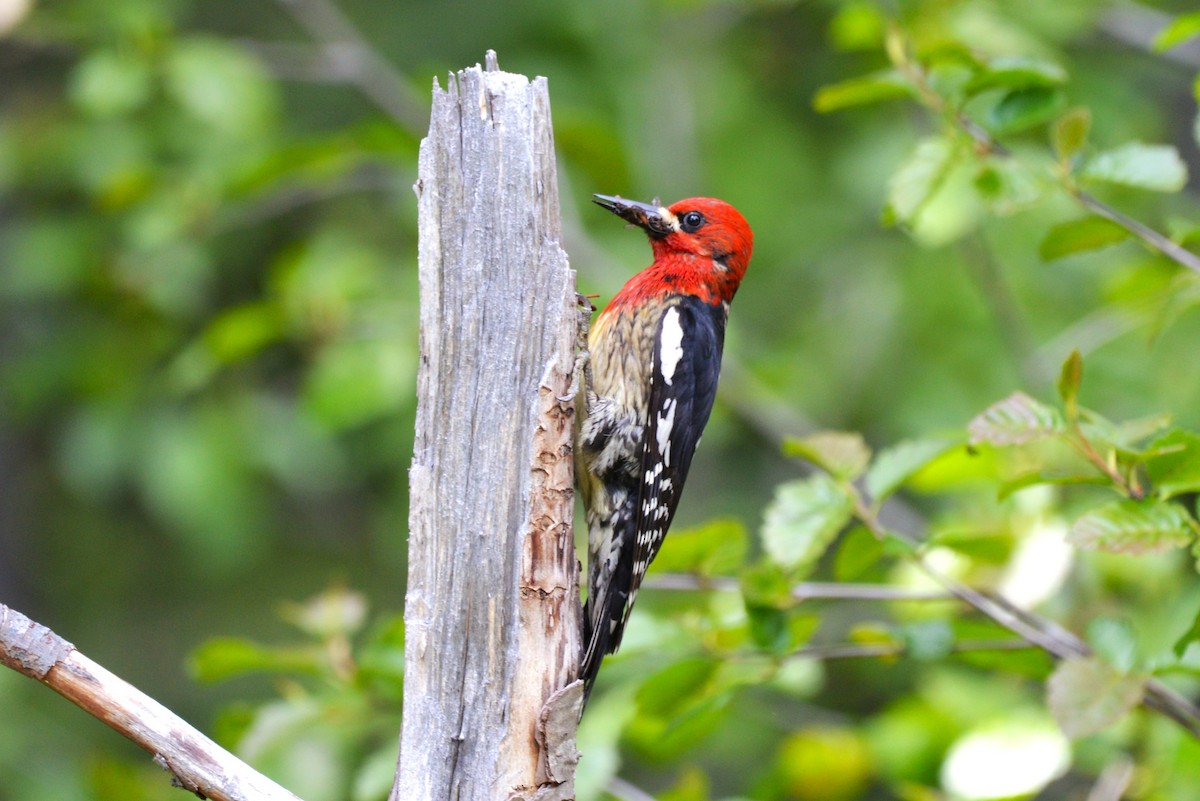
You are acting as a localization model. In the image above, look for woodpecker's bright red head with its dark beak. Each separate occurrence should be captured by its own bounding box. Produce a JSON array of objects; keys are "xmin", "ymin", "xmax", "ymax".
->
[{"xmin": 595, "ymin": 194, "xmax": 754, "ymax": 303}]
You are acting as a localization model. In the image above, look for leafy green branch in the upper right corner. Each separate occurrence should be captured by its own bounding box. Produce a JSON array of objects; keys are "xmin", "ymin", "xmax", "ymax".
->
[{"xmin": 814, "ymin": 24, "xmax": 1200, "ymax": 273}]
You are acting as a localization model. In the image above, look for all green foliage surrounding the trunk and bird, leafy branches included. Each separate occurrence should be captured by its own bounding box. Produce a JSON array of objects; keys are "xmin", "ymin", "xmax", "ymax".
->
[{"xmin": 7, "ymin": 0, "xmax": 1200, "ymax": 801}]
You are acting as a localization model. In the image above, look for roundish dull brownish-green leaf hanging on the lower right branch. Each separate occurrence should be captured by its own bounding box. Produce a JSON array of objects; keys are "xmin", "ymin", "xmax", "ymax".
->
[{"xmin": 1046, "ymin": 657, "xmax": 1146, "ymax": 737}]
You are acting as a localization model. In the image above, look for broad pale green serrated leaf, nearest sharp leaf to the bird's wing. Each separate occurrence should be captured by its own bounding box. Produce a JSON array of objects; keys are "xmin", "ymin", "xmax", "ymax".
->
[{"xmin": 762, "ymin": 475, "xmax": 854, "ymax": 579}]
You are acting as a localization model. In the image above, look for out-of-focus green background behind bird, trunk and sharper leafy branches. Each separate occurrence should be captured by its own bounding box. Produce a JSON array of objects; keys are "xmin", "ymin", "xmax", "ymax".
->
[{"xmin": 0, "ymin": 0, "xmax": 1200, "ymax": 801}]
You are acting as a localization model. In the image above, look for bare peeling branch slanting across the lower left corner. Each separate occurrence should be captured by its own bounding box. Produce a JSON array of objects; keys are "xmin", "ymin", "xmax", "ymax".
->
[{"xmin": 0, "ymin": 604, "xmax": 300, "ymax": 801}]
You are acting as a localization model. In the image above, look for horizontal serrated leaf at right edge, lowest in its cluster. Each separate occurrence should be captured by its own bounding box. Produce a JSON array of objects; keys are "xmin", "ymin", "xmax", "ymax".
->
[{"xmin": 1067, "ymin": 499, "xmax": 1192, "ymax": 555}]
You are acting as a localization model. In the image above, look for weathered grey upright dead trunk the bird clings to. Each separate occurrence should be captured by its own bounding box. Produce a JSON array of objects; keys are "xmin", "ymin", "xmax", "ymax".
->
[{"xmin": 391, "ymin": 53, "xmax": 580, "ymax": 801}]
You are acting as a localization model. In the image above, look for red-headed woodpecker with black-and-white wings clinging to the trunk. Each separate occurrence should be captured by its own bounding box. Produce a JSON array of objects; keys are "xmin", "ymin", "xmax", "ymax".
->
[{"xmin": 576, "ymin": 194, "xmax": 754, "ymax": 703}]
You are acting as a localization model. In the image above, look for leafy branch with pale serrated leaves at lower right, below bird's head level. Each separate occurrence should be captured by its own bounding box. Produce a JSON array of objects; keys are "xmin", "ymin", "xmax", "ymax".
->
[{"xmin": 763, "ymin": 353, "xmax": 1200, "ymax": 736}]
